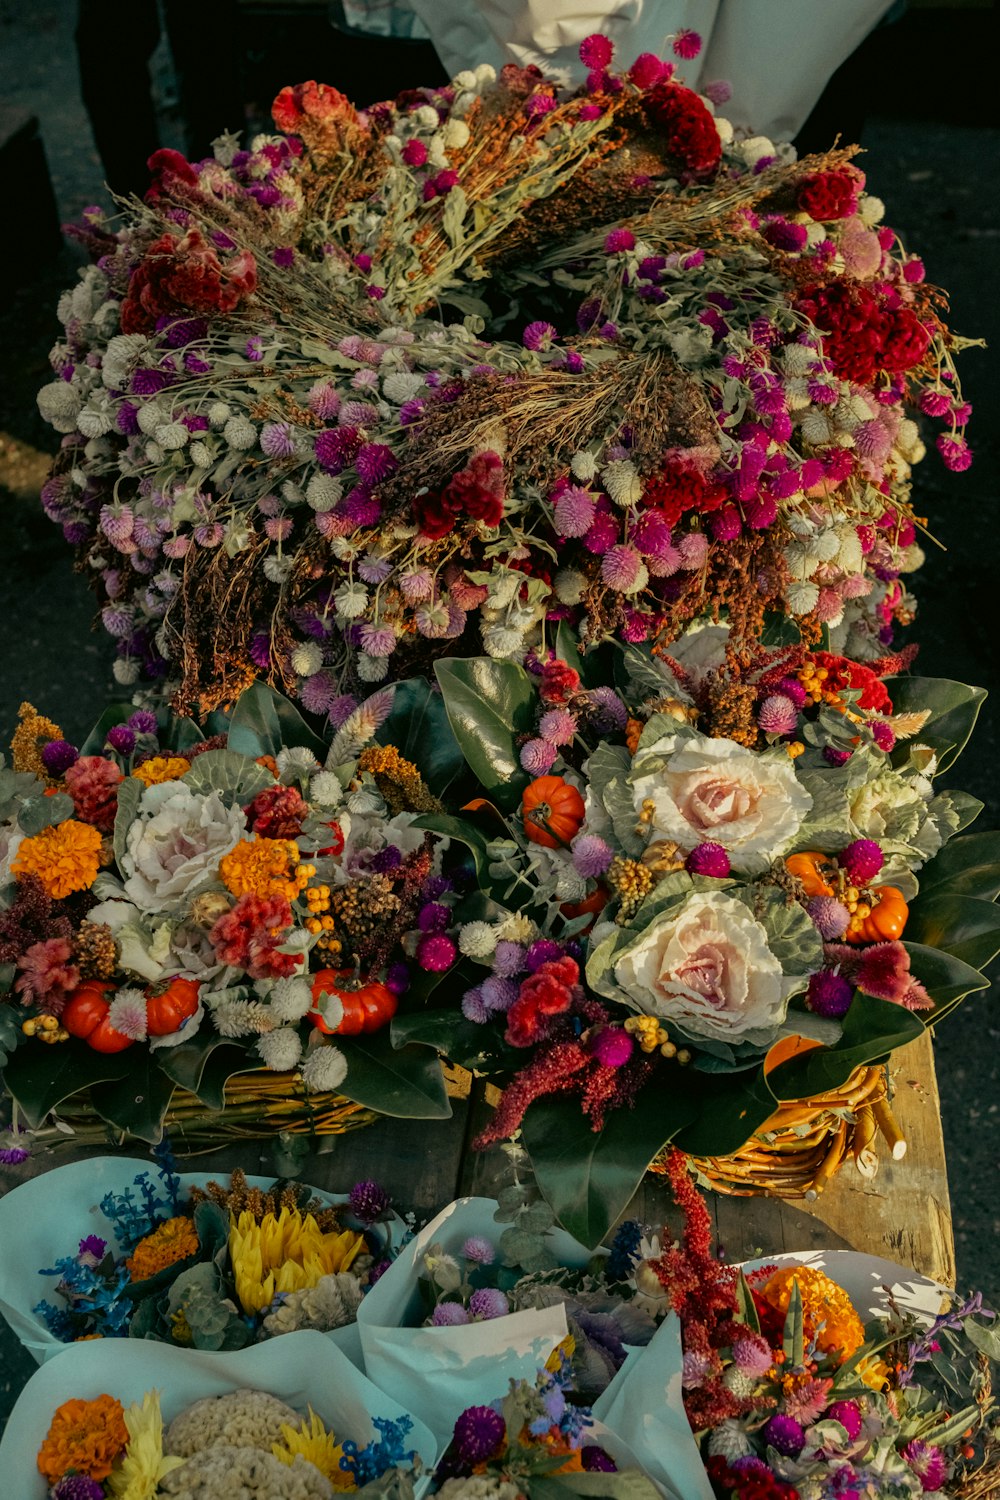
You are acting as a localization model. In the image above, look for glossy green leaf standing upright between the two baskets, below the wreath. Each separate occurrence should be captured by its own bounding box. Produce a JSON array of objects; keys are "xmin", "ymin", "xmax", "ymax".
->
[{"xmin": 435, "ymin": 657, "xmax": 535, "ymax": 813}]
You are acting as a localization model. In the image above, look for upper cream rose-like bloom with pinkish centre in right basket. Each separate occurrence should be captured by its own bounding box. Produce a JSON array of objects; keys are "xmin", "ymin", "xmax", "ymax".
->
[{"xmin": 631, "ymin": 734, "xmax": 813, "ymax": 875}]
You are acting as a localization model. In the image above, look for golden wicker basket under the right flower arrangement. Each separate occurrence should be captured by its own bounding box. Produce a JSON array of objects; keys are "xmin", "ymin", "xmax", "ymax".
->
[{"xmin": 651, "ymin": 1067, "xmax": 906, "ymax": 1200}]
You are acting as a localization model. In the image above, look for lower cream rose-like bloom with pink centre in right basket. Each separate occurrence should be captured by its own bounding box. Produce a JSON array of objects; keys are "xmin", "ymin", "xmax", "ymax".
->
[{"xmin": 615, "ymin": 891, "xmax": 798, "ymax": 1046}]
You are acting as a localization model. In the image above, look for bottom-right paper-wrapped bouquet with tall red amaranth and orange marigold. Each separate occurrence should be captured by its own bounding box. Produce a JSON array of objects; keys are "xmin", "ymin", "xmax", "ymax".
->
[{"xmin": 593, "ymin": 1154, "xmax": 1000, "ymax": 1500}]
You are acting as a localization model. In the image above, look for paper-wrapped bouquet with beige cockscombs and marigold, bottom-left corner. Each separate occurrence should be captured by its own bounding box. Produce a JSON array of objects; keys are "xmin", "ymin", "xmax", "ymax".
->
[{"xmin": 0, "ymin": 1334, "xmax": 436, "ymax": 1500}]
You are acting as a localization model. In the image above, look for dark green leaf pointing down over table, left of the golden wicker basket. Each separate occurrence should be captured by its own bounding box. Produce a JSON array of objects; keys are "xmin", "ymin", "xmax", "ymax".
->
[{"xmin": 522, "ymin": 1083, "xmax": 699, "ymax": 1250}]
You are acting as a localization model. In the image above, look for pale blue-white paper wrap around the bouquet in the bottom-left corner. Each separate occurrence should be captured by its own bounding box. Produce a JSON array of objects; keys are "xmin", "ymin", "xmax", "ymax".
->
[{"xmin": 0, "ymin": 1332, "xmax": 438, "ymax": 1500}]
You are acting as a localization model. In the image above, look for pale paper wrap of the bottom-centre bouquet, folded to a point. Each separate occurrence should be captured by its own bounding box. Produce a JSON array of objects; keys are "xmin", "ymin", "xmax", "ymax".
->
[{"xmin": 358, "ymin": 1199, "xmax": 591, "ymax": 1446}]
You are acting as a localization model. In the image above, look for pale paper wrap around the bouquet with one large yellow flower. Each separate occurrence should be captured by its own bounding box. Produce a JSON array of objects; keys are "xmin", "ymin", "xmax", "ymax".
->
[{"xmin": 0, "ymin": 1157, "xmax": 405, "ymax": 1370}]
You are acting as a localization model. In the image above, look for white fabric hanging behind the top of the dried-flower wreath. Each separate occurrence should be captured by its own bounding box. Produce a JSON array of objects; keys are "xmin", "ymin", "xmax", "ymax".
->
[{"xmin": 411, "ymin": 0, "xmax": 892, "ymax": 140}]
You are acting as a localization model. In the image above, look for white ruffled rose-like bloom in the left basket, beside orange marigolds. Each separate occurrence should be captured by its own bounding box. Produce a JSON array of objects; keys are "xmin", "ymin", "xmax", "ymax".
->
[{"xmin": 121, "ymin": 782, "xmax": 246, "ymax": 912}]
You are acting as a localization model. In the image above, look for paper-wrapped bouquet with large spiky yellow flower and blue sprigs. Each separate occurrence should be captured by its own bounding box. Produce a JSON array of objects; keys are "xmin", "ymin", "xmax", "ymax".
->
[{"xmin": 0, "ymin": 1148, "xmax": 408, "ymax": 1367}]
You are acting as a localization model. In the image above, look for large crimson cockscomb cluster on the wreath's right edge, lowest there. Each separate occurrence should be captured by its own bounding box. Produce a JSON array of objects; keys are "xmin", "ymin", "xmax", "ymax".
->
[{"xmin": 798, "ymin": 282, "xmax": 931, "ymax": 386}]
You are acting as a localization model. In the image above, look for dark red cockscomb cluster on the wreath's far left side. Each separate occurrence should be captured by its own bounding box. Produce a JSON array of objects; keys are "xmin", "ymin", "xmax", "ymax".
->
[{"xmin": 121, "ymin": 230, "xmax": 256, "ymax": 333}]
